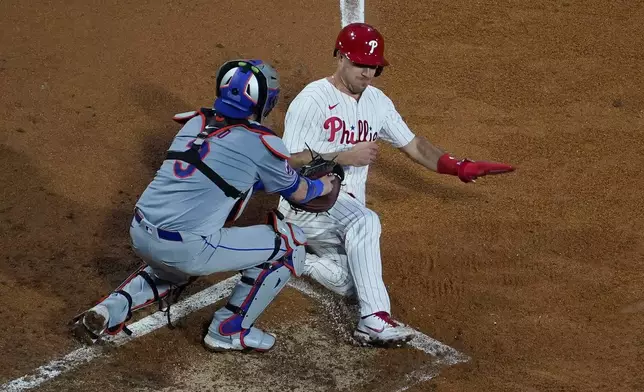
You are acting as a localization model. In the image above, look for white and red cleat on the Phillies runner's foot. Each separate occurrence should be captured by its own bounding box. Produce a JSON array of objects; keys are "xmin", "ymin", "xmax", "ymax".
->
[{"xmin": 353, "ymin": 312, "xmax": 413, "ymax": 348}]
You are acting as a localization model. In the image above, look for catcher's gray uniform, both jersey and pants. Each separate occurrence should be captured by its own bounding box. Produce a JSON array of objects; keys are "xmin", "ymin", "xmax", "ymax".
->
[{"xmin": 103, "ymin": 111, "xmax": 304, "ymax": 350}]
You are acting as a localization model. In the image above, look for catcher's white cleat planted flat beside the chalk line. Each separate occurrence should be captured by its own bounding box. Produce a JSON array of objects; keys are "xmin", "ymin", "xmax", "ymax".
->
[{"xmin": 203, "ymin": 327, "xmax": 275, "ymax": 352}]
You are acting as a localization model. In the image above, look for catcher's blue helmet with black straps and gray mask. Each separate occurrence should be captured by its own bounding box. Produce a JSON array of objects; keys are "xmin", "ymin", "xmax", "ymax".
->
[{"xmin": 213, "ymin": 60, "xmax": 280, "ymax": 122}]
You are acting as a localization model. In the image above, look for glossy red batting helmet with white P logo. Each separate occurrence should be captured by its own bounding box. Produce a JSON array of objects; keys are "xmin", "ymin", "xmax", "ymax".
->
[{"xmin": 333, "ymin": 23, "xmax": 389, "ymax": 67}]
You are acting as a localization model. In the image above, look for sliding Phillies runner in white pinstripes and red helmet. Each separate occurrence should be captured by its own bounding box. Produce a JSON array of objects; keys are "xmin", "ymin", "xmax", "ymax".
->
[{"xmin": 279, "ymin": 23, "xmax": 514, "ymax": 346}]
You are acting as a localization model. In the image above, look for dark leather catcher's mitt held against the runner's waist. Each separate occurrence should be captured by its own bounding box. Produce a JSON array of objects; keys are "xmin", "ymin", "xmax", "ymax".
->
[{"xmin": 287, "ymin": 151, "xmax": 344, "ymax": 214}]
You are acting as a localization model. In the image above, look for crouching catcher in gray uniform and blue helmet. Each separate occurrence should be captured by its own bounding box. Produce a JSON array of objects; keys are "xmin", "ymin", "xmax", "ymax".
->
[{"xmin": 72, "ymin": 60, "xmax": 341, "ymax": 351}]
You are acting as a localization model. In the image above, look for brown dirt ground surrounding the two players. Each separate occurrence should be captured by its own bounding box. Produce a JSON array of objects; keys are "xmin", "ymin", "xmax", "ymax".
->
[{"xmin": 0, "ymin": 0, "xmax": 644, "ymax": 391}]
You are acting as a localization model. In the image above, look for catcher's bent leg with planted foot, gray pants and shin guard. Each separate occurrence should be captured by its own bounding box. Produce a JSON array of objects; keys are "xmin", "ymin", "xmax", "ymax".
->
[{"xmin": 124, "ymin": 213, "xmax": 306, "ymax": 351}]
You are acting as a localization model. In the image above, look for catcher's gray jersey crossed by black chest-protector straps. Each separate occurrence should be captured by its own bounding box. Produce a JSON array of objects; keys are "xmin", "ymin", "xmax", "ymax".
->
[{"xmin": 136, "ymin": 116, "xmax": 298, "ymax": 235}]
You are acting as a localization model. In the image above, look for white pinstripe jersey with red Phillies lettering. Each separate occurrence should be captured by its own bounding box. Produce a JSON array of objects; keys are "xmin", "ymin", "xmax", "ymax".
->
[{"xmin": 282, "ymin": 78, "xmax": 415, "ymax": 203}]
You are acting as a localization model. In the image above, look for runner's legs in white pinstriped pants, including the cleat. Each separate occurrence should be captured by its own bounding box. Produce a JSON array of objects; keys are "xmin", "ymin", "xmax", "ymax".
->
[{"xmin": 280, "ymin": 196, "xmax": 412, "ymax": 345}]
